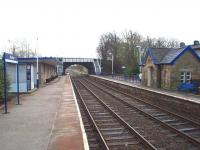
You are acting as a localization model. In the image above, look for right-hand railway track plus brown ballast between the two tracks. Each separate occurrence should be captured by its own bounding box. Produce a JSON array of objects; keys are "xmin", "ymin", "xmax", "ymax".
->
[{"xmin": 79, "ymin": 79, "xmax": 200, "ymax": 149}]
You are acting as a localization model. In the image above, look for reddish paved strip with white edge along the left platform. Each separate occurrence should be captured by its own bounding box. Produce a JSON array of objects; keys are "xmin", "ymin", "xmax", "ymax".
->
[{"xmin": 48, "ymin": 77, "xmax": 89, "ymax": 150}]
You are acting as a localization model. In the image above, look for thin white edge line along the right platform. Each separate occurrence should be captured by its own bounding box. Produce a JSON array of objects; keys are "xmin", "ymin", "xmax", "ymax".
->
[{"xmin": 92, "ymin": 75, "xmax": 200, "ymax": 104}]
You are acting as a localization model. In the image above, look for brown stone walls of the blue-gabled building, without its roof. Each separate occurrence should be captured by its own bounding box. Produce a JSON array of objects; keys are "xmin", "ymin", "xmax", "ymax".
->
[{"xmin": 142, "ymin": 51, "xmax": 200, "ymax": 89}]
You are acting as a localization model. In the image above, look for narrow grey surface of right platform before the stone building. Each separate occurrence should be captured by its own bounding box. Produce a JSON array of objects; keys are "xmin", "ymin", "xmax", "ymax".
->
[{"xmin": 95, "ymin": 76, "xmax": 200, "ymax": 104}]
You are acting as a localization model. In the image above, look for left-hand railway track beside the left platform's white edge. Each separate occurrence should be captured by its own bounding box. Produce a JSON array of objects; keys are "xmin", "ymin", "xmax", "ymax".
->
[{"xmin": 73, "ymin": 80, "xmax": 156, "ymax": 150}]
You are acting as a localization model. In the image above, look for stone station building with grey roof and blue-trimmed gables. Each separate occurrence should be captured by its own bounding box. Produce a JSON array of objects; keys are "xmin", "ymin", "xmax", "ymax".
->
[{"xmin": 142, "ymin": 44, "xmax": 200, "ymax": 89}]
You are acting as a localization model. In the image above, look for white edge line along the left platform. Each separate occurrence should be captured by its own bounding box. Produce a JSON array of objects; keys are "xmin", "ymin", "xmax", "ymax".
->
[{"xmin": 68, "ymin": 76, "xmax": 89, "ymax": 150}]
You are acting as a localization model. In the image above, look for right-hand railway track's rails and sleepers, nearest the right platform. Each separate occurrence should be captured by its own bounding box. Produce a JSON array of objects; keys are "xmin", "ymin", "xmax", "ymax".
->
[{"xmin": 86, "ymin": 77, "xmax": 200, "ymax": 145}]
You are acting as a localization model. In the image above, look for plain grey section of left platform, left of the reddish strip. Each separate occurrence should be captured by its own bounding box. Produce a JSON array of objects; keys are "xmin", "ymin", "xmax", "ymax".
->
[{"xmin": 0, "ymin": 78, "xmax": 64, "ymax": 150}]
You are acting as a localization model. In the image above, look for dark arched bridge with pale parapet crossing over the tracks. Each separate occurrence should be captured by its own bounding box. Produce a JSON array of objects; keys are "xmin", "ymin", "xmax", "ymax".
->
[{"xmin": 62, "ymin": 58, "xmax": 101, "ymax": 74}]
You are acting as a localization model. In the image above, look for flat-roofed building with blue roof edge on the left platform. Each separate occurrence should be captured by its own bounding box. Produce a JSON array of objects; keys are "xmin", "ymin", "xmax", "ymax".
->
[{"xmin": 18, "ymin": 57, "xmax": 60, "ymax": 92}]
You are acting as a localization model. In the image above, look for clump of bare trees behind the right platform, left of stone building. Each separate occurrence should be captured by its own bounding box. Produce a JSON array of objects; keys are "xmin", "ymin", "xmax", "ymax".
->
[{"xmin": 97, "ymin": 30, "xmax": 179, "ymax": 74}]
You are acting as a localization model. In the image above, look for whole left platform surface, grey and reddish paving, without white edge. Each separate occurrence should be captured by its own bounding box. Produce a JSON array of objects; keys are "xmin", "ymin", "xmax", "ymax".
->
[{"xmin": 0, "ymin": 76, "xmax": 87, "ymax": 150}]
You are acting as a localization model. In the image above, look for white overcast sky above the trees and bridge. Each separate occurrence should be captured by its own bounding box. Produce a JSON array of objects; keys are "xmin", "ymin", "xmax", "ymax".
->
[{"xmin": 0, "ymin": 0, "xmax": 200, "ymax": 57}]
